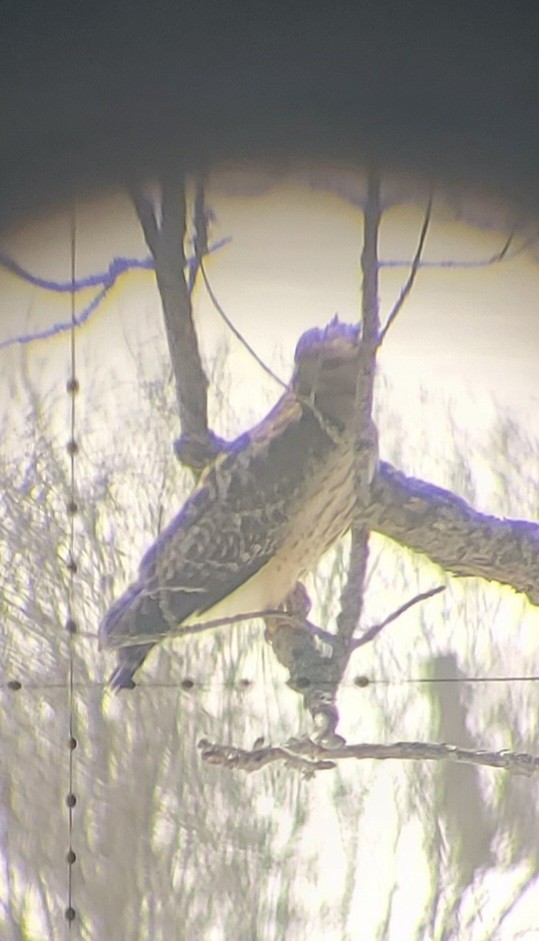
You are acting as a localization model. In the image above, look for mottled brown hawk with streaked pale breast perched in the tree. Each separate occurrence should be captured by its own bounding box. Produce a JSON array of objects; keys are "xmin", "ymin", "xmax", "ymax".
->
[{"xmin": 99, "ymin": 318, "xmax": 377, "ymax": 689}]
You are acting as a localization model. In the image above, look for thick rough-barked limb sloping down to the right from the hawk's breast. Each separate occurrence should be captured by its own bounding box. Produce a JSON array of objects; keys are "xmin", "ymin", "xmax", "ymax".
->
[{"xmin": 372, "ymin": 461, "xmax": 539, "ymax": 604}]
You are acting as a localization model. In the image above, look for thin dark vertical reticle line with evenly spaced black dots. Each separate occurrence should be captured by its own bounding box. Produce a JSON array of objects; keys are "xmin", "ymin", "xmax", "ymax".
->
[{"xmin": 65, "ymin": 207, "xmax": 79, "ymax": 933}]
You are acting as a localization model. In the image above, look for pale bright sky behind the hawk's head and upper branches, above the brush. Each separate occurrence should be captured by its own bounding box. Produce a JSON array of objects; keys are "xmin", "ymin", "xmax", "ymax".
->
[{"xmin": 4, "ymin": 168, "xmax": 539, "ymax": 420}]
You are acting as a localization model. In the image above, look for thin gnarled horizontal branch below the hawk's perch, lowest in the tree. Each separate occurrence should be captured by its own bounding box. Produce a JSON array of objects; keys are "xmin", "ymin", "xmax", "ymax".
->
[{"xmin": 198, "ymin": 738, "xmax": 539, "ymax": 777}]
